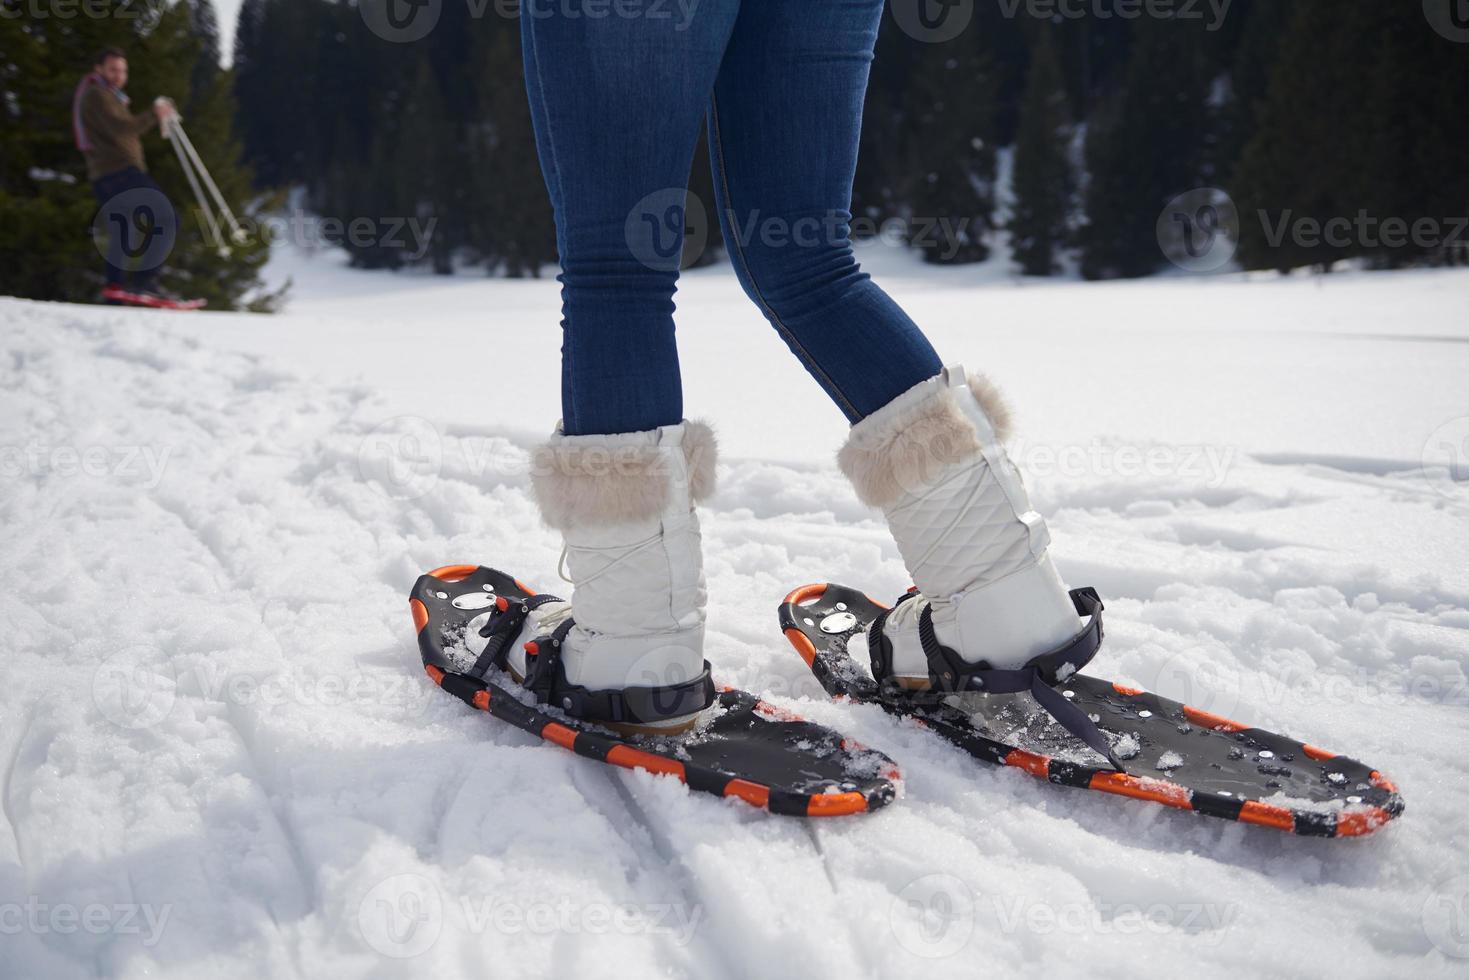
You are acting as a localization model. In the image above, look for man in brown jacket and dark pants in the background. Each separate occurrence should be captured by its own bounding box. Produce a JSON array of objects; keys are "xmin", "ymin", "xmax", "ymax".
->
[{"xmin": 72, "ymin": 47, "xmax": 178, "ymax": 306}]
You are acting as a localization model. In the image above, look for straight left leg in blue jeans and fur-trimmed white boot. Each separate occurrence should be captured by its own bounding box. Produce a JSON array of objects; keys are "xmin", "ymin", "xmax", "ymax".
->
[{"xmin": 517, "ymin": 0, "xmax": 737, "ymax": 732}]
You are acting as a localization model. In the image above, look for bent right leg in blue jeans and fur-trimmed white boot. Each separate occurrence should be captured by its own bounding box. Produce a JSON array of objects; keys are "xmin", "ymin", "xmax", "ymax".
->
[{"xmin": 711, "ymin": 0, "xmax": 1081, "ymax": 686}]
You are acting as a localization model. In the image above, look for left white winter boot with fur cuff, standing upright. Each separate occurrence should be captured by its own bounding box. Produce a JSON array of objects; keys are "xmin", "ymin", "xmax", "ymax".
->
[{"xmin": 487, "ymin": 422, "xmax": 717, "ymax": 735}]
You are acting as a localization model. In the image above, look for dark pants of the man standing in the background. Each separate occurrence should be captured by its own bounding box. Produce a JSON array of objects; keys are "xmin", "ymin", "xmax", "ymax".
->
[{"xmin": 93, "ymin": 167, "xmax": 178, "ymax": 291}]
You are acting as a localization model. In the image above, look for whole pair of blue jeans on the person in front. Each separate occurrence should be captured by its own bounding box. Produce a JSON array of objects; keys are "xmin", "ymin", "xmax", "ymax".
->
[{"xmin": 520, "ymin": 0, "xmax": 942, "ymax": 435}]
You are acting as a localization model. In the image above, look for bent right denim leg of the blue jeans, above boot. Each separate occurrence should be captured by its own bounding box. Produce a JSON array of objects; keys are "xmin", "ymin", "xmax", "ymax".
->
[{"xmin": 710, "ymin": 0, "xmax": 943, "ymax": 422}]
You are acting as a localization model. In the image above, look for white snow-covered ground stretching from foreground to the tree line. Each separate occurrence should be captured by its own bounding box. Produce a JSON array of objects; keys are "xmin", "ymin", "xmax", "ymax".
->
[{"xmin": 0, "ymin": 248, "xmax": 1469, "ymax": 979}]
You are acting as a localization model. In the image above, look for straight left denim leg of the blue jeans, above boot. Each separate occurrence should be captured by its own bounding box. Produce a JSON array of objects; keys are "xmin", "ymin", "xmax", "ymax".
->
[{"xmin": 520, "ymin": 0, "xmax": 739, "ymax": 435}]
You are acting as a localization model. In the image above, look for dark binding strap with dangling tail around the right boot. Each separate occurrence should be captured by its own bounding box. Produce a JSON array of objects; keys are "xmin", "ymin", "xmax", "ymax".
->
[{"xmin": 867, "ymin": 588, "xmax": 1127, "ymax": 773}]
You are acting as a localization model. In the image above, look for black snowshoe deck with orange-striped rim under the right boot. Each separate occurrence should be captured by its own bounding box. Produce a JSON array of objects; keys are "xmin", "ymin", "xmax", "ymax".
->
[{"xmin": 780, "ymin": 585, "xmax": 1403, "ymax": 837}]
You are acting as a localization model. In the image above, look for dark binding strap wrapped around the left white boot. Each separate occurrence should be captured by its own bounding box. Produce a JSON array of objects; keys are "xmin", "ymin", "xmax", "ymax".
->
[{"xmin": 523, "ymin": 619, "xmax": 715, "ymax": 724}]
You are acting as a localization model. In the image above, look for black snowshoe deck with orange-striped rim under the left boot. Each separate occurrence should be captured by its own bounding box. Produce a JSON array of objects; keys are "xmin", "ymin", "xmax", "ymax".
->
[{"xmin": 408, "ymin": 566, "xmax": 899, "ymax": 817}]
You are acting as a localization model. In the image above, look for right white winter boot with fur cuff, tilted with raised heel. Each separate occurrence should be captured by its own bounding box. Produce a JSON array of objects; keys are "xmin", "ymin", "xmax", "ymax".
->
[{"xmin": 839, "ymin": 367, "xmax": 1100, "ymax": 691}]
